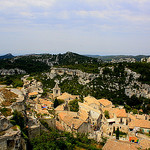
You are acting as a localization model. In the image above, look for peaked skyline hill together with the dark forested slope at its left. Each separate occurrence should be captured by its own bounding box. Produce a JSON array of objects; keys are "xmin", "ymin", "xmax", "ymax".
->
[{"xmin": 0, "ymin": 52, "xmax": 101, "ymax": 73}]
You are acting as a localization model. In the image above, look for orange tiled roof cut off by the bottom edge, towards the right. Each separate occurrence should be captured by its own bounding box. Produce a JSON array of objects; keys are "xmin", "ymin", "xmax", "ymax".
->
[{"xmin": 102, "ymin": 140, "xmax": 139, "ymax": 150}]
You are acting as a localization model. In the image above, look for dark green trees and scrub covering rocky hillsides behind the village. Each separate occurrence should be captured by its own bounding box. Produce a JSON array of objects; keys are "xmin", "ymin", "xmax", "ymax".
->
[{"xmin": 0, "ymin": 52, "xmax": 150, "ymax": 113}]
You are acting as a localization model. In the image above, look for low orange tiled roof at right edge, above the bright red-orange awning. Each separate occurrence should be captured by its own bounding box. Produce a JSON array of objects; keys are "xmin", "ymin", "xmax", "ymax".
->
[{"xmin": 128, "ymin": 119, "xmax": 150, "ymax": 129}]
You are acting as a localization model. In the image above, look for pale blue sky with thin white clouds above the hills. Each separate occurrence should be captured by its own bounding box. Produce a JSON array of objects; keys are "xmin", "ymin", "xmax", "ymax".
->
[{"xmin": 0, "ymin": 0, "xmax": 150, "ymax": 55}]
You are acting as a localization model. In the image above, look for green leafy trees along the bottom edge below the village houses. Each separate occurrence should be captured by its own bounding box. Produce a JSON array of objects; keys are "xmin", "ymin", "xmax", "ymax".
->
[{"xmin": 31, "ymin": 129, "xmax": 100, "ymax": 150}]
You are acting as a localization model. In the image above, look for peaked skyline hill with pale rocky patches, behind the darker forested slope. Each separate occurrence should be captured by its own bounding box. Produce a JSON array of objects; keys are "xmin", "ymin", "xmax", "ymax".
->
[{"xmin": 15, "ymin": 52, "xmax": 100, "ymax": 66}]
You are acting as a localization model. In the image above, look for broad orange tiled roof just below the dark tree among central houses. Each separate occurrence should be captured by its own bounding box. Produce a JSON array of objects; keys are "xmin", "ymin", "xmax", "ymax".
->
[{"xmin": 58, "ymin": 111, "xmax": 85, "ymax": 129}]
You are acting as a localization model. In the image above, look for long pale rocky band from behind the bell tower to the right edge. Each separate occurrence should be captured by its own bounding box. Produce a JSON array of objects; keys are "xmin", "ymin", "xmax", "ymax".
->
[{"xmin": 44, "ymin": 67, "xmax": 150, "ymax": 98}]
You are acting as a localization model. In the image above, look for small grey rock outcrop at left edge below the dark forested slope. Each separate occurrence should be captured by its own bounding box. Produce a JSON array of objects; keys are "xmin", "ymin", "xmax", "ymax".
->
[{"xmin": 0, "ymin": 68, "xmax": 26, "ymax": 75}]
